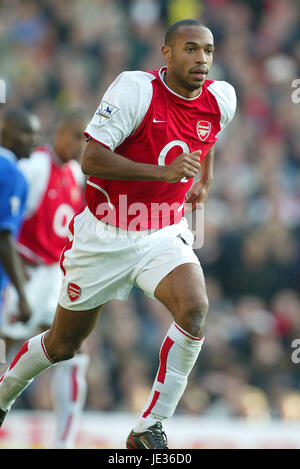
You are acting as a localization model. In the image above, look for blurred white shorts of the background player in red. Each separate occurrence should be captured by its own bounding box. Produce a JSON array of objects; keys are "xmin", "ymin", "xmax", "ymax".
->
[{"xmin": 0, "ymin": 263, "xmax": 62, "ymax": 340}]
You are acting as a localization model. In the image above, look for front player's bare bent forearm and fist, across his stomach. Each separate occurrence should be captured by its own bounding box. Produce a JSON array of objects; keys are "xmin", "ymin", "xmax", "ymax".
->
[{"xmin": 81, "ymin": 140, "xmax": 201, "ymax": 182}]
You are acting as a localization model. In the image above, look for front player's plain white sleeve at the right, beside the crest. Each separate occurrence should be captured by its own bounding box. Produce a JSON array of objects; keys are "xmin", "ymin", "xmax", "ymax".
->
[{"xmin": 208, "ymin": 81, "xmax": 236, "ymax": 131}]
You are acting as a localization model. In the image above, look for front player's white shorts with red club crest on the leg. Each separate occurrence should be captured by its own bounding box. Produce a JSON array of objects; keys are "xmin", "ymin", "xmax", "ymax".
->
[{"xmin": 59, "ymin": 207, "xmax": 200, "ymax": 311}]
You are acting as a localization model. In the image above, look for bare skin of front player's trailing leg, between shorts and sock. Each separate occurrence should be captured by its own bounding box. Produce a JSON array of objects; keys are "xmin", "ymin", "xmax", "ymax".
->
[{"xmin": 45, "ymin": 304, "xmax": 102, "ymax": 361}]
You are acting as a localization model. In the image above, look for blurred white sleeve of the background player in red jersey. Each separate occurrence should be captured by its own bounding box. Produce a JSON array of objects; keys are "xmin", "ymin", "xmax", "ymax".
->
[{"xmin": 18, "ymin": 151, "xmax": 51, "ymax": 218}]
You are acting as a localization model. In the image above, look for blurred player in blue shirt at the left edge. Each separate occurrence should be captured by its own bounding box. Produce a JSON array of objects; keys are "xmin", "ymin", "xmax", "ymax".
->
[{"xmin": 0, "ymin": 109, "xmax": 39, "ymax": 321}]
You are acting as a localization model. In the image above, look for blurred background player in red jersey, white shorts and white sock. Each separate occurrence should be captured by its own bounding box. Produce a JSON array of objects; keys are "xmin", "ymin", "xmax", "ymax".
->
[{"xmin": 0, "ymin": 112, "xmax": 88, "ymax": 449}]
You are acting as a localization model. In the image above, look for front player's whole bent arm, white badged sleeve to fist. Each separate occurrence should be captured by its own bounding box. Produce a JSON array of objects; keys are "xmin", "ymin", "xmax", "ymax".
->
[{"xmin": 81, "ymin": 72, "xmax": 200, "ymax": 182}]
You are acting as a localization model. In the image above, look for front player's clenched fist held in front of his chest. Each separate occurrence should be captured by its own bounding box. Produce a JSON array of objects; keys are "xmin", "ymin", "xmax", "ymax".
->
[{"xmin": 164, "ymin": 150, "xmax": 202, "ymax": 182}]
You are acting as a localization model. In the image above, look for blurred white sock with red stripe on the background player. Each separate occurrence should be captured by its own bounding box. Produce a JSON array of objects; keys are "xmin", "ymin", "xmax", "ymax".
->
[{"xmin": 52, "ymin": 353, "xmax": 89, "ymax": 449}]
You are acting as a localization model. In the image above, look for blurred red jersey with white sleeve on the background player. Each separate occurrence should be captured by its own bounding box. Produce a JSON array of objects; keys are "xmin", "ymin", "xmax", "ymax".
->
[{"xmin": 18, "ymin": 146, "xmax": 84, "ymax": 264}]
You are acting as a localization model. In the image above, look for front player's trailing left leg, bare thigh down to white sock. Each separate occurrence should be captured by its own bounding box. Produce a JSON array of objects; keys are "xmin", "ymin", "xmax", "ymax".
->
[{"xmin": 0, "ymin": 305, "xmax": 101, "ymax": 424}]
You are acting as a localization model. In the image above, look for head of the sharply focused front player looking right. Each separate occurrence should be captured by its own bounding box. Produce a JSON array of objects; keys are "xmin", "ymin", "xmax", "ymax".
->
[{"xmin": 163, "ymin": 26, "xmax": 214, "ymax": 98}]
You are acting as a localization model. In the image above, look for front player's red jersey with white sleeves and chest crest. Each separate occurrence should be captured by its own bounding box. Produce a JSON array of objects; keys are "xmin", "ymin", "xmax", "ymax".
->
[{"xmin": 85, "ymin": 67, "xmax": 236, "ymax": 230}]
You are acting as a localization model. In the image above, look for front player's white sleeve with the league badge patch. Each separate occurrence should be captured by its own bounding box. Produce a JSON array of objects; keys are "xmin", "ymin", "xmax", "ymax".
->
[{"xmin": 85, "ymin": 72, "xmax": 154, "ymax": 151}]
